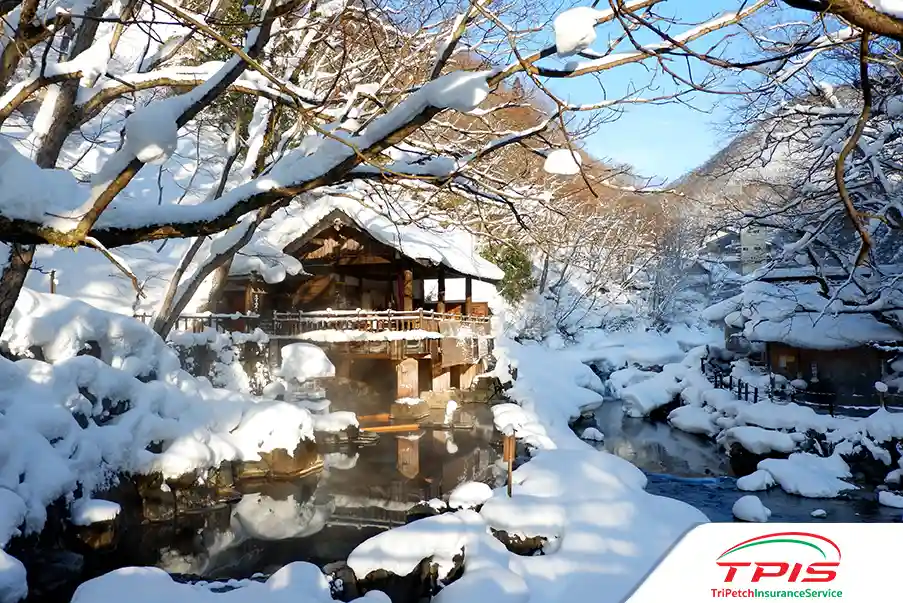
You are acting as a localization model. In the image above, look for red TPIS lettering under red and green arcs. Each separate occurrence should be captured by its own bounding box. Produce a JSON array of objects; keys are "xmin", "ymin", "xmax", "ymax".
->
[{"xmin": 715, "ymin": 532, "xmax": 841, "ymax": 584}]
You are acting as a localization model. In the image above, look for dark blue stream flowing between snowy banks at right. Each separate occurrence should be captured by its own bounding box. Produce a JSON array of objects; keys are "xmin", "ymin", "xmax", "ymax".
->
[{"xmin": 595, "ymin": 400, "xmax": 903, "ymax": 523}]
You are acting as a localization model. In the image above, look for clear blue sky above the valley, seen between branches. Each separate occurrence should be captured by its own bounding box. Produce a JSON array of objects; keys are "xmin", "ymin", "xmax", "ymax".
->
[{"xmin": 550, "ymin": 0, "xmax": 780, "ymax": 181}]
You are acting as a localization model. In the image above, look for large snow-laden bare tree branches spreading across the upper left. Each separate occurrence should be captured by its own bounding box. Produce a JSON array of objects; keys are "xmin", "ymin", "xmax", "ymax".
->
[{"xmin": 0, "ymin": 0, "xmax": 784, "ymax": 332}]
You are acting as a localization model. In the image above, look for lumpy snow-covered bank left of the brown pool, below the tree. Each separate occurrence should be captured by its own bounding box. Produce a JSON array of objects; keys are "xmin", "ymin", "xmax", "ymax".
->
[{"xmin": 0, "ymin": 291, "xmax": 313, "ymax": 576}]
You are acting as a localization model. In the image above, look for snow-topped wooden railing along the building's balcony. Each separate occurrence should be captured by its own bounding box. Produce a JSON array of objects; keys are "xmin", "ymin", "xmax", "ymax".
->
[{"xmin": 135, "ymin": 309, "xmax": 490, "ymax": 337}]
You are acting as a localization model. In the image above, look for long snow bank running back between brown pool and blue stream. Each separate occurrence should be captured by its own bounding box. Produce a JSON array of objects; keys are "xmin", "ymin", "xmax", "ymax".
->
[{"xmin": 462, "ymin": 326, "xmax": 707, "ymax": 603}]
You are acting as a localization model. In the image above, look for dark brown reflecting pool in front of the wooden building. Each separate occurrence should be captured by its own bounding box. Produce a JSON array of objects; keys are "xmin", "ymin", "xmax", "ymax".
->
[{"xmin": 23, "ymin": 405, "xmax": 499, "ymax": 603}]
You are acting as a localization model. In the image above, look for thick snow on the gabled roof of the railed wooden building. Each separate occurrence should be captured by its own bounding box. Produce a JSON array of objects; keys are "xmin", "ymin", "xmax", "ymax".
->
[{"xmin": 231, "ymin": 195, "xmax": 505, "ymax": 283}]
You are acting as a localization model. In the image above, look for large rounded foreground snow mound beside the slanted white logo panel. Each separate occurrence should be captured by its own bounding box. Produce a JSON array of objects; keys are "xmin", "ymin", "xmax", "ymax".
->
[{"xmin": 348, "ymin": 448, "xmax": 706, "ymax": 603}]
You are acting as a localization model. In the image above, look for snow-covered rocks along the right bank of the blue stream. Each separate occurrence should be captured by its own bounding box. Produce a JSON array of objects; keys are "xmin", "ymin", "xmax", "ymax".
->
[{"xmin": 600, "ymin": 346, "xmax": 903, "ymax": 497}]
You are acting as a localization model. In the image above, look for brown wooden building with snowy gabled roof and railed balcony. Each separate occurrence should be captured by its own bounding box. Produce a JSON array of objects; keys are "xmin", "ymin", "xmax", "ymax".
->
[{"xmin": 216, "ymin": 196, "xmax": 504, "ymax": 408}]
